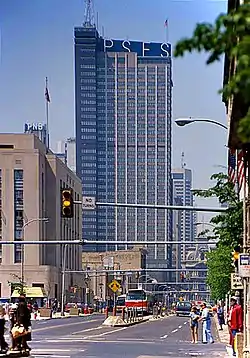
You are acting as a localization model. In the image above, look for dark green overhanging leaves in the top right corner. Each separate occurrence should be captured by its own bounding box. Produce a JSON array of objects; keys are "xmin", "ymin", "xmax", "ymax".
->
[{"xmin": 174, "ymin": 0, "xmax": 250, "ymax": 143}]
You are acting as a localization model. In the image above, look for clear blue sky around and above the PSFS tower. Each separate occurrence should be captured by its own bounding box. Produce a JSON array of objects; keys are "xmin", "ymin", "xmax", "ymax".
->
[{"xmin": 0, "ymin": 0, "xmax": 227, "ymax": 227}]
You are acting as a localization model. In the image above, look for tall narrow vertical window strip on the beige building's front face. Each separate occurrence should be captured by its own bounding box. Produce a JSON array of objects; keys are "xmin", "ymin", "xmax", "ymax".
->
[{"xmin": 14, "ymin": 169, "xmax": 23, "ymax": 263}]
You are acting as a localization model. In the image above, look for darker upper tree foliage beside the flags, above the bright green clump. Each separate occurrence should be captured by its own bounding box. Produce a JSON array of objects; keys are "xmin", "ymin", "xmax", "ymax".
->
[{"xmin": 194, "ymin": 173, "xmax": 243, "ymax": 251}]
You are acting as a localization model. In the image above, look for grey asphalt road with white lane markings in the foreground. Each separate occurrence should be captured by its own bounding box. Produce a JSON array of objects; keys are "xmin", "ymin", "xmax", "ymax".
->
[{"xmin": 6, "ymin": 315, "xmax": 227, "ymax": 358}]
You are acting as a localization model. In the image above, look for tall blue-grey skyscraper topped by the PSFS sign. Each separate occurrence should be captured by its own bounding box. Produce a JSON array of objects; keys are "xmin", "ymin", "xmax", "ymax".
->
[{"xmin": 75, "ymin": 23, "xmax": 172, "ymax": 276}]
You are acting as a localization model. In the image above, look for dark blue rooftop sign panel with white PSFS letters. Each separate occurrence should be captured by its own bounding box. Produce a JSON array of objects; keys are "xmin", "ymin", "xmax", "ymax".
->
[{"xmin": 101, "ymin": 39, "xmax": 171, "ymax": 57}]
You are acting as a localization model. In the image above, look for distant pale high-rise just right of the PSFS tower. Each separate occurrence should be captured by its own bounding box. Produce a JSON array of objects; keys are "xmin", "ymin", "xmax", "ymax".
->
[{"xmin": 172, "ymin": 167, "xmax": 196, "ymax": 260}]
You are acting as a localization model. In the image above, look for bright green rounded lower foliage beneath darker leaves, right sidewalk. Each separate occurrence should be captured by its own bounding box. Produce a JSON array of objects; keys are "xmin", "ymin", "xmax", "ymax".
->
[{"xmin": 206, "ymin": 245, "xmax": 233, "ymax": 300}]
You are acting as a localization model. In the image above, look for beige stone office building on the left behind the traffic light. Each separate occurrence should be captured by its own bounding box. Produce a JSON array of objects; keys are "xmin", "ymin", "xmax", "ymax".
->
[{"xmin": 0, "ymin": 134, "xmax": 82, "ymax": 298}]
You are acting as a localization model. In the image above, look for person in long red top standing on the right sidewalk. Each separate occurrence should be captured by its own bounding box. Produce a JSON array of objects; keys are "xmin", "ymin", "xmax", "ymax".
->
[{"xmin": 228, "ymin": 297, "xmax": 243, "ymax": 356}]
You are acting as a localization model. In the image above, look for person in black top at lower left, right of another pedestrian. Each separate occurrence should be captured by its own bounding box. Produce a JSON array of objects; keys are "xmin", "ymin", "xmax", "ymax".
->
[{"xmin": 17, "ymin": 295, "xmax": 31, "ymax": 352}]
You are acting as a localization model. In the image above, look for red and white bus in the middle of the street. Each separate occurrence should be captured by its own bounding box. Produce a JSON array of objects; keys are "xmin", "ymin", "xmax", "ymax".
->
[{"xmin": 125, "ymin": 289, "xmax": 155, "ymax": 314}]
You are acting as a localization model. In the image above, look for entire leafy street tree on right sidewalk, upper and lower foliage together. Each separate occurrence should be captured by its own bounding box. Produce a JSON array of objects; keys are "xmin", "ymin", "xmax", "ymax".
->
[{"xmin": 191, "ymin": 173, "xmax": 243, "ymax": 299}]
